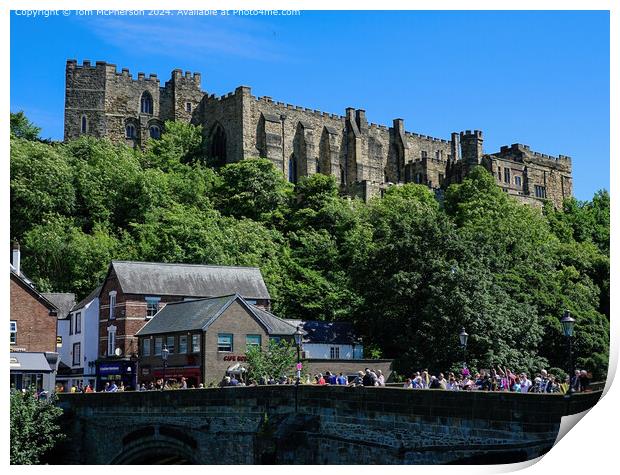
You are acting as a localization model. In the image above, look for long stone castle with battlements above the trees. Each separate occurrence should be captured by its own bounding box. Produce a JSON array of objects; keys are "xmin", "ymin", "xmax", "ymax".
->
[{"xmin": 64, "ymin": 60, "xmax": 572, "ymax": 207}]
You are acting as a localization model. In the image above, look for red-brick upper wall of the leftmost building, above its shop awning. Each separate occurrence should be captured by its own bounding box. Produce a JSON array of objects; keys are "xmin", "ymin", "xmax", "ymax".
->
[{"xmin": 11, "ymin": 274, "xmax": 56, "ymax": 352}]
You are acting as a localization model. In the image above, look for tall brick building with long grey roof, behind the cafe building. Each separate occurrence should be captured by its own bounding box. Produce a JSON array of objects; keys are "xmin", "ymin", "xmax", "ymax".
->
[{"xmin": 96, "ymin": 261, "xmax": 271, "ymax": 389}]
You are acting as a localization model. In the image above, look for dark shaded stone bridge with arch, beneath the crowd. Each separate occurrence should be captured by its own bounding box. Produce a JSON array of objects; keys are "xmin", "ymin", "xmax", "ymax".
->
[{"xmin": 53, "ymin": 386, "xmax": 601, "ymax": 464}]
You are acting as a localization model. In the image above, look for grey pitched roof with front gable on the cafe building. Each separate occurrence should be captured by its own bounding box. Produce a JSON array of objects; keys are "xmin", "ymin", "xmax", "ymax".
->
[{"xmin": 136, "ymin": 294, "xmax": 296, "ymax": 336}]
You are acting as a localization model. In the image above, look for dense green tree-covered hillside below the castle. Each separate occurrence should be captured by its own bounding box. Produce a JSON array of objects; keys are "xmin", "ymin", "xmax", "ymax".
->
[{"xmin": 11, "ymin": 114, "xmax": 609, "ymax": 378}]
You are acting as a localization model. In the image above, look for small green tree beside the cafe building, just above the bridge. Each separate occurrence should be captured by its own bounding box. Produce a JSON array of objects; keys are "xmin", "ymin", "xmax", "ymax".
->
[{"xmin": 245, "ymin": 340, "xmax": 297, "ymax": 382}]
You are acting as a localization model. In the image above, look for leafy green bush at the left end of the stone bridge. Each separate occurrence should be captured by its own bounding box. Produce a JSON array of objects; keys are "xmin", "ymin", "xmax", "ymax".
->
[{"xmin": 10, "ymin": 391, "xmax": 64, "ymax": 465}]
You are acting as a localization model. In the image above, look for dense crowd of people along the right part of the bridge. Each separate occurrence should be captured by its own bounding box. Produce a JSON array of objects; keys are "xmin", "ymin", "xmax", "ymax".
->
[{"xmin": 403, "ymin": 368, "xmax": 591, "ymax": 394}]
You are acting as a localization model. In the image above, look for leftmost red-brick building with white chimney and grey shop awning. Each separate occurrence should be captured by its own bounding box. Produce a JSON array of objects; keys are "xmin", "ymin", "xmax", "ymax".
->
[{"xmin": 10, "ymin": 243, "xmax": 59, "ymax": 391}]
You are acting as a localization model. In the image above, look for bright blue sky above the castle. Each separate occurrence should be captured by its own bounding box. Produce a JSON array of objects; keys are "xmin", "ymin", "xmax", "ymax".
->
[{"xmin": 11, "ymin": 11, "xmax": 609, "ymax": 199}]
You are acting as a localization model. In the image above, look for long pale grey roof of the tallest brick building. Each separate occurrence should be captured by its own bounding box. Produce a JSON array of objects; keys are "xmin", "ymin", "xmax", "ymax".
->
[{"xmin": 111, "ymin": 261, "xmax": 271, "ymax": 300}]
